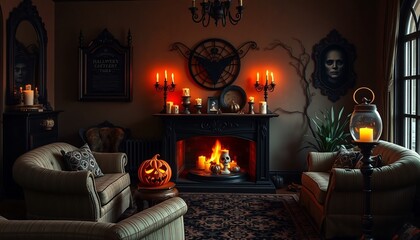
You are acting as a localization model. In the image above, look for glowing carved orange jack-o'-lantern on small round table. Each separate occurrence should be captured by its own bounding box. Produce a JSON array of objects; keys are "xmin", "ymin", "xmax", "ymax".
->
[{"xmin": 137, "ymin": 154, "xmax": 172, "ymax": 187}]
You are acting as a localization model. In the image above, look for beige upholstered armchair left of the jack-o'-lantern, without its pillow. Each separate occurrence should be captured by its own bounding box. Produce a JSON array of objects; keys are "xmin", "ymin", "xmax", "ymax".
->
[{"xmin": 13, "ymin": 142, "xmax": 132, "ymax": 222}]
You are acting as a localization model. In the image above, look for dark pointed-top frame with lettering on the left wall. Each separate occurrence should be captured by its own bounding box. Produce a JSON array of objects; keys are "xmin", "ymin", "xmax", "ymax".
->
[{"xmin": 79, "ymin": 29, "xmax": 132, "ymax": 101}]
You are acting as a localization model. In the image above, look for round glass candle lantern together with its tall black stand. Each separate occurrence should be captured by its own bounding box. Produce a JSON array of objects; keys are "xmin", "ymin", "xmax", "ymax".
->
[{"xmin": 349, "ymin": 87, "xmax": 382, "ymax": 239}]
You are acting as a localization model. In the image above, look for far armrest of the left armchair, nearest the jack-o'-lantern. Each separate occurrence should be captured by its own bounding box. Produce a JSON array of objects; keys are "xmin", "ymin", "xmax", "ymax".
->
[{"xmin": 92, "ymin": 152, "xmax": 127, "ymax": 173}]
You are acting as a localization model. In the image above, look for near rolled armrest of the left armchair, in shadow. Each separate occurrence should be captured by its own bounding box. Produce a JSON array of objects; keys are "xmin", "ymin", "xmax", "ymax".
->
[{"xmin": 13, "ymin": 165, "xmax": 95, "ymax": 195}]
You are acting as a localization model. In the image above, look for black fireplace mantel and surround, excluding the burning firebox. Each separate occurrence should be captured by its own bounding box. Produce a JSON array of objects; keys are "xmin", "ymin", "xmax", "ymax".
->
[{"xmin": 154, "ymin": 113, "xmax": 278, "ymax": 192}]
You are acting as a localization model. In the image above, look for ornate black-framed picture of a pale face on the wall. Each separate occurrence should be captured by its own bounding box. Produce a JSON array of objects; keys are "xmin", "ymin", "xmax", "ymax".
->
[{"xmin": 312, "ymin": 29, "xmax": 356, "ymax": 102}]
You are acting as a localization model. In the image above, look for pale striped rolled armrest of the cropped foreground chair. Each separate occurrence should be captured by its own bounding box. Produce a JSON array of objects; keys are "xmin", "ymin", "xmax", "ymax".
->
[{"xmin": 111, "ymin": 197, "xmax": 188, "ymax": 240}]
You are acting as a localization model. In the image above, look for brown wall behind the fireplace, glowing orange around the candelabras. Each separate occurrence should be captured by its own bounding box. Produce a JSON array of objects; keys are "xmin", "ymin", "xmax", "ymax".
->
[{"xmin": 0, "ymin": 0, "xmax": 383, "ymax": 174}]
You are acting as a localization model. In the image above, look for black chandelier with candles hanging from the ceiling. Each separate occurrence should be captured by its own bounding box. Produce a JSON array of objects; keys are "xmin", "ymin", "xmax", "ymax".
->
[{"xmin": 190, "ymin": 0, "xmax": 244, "ymax": 27}]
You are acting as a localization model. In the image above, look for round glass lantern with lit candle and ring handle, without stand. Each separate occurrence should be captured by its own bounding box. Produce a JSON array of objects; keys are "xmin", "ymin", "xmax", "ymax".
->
[{"xmin": 349, "ymin": 87, "xmax": 382, "ymax": 142}]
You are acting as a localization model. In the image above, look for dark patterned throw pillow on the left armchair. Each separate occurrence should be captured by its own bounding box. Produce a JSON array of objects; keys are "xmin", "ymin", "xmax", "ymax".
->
[{"xmin": 61, "ymin": 144, "xmax": 104, "ymax": 177}]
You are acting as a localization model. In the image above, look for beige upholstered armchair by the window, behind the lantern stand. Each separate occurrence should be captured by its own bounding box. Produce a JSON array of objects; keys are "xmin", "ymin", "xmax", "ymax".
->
[{"xmin": 300, "ymin": 141, "xmax": 420, "ymax": 239}]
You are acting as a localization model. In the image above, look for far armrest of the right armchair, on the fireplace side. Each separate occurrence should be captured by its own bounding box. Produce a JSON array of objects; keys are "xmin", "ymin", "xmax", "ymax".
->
[{"xmin": 306, "ymin": 152, "xmax": 337, "ymax": 172}]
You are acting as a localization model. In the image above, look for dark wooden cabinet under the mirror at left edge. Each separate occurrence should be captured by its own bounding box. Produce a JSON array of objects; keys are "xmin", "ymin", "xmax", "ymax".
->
[{"xmin": 3, "ymin": 111, "xmax": 60, "ymax": 197}]
